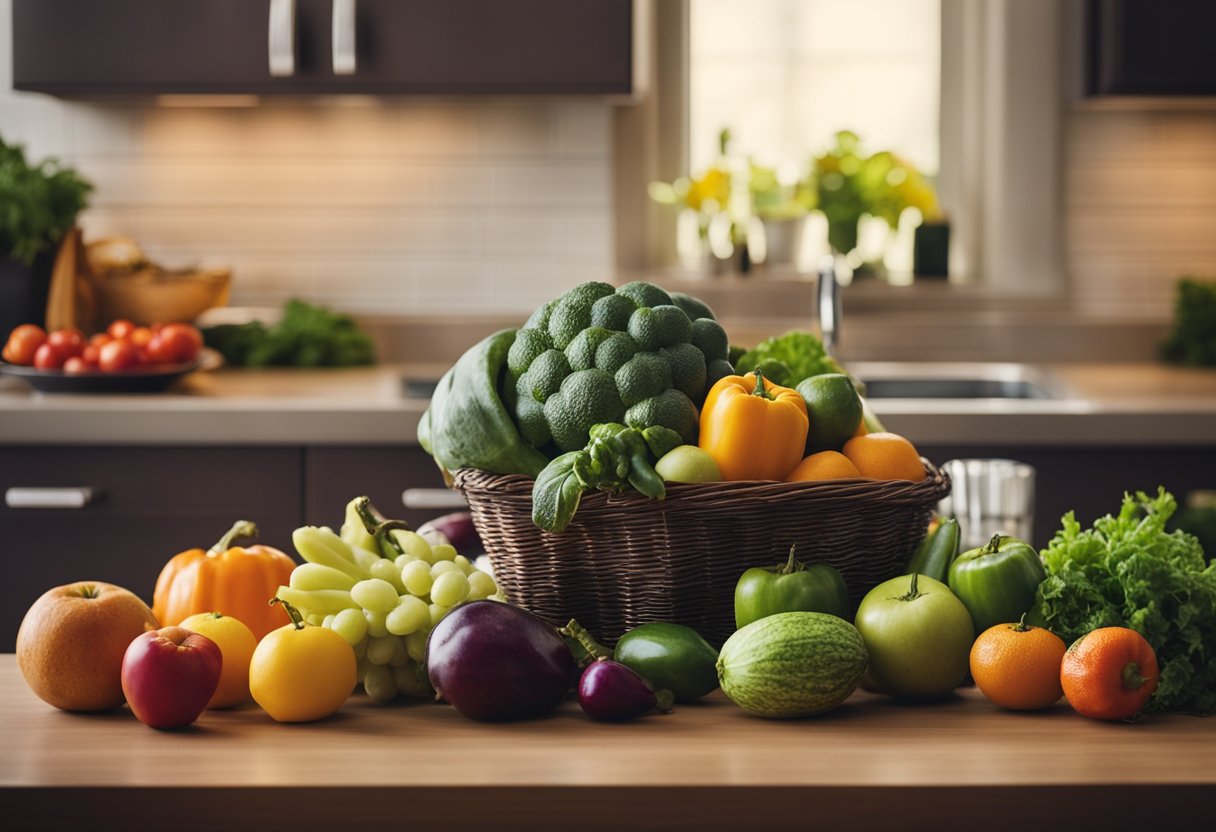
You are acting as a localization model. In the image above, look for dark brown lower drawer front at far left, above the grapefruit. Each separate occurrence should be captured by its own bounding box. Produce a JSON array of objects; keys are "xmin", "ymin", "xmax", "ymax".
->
[{"xmin": 0, "ymin": 446, "xmax": 303, "ymax": 652}]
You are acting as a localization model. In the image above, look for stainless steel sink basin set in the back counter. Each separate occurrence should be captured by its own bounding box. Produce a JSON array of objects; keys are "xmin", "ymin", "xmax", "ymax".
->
[{"xmin": 849, "ymin": 361, "xmax": 1068, "ymax": 400}]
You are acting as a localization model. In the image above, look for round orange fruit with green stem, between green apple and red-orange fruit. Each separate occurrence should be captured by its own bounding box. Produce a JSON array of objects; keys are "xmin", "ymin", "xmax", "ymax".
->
[{"xmin": 970, "ymin": 623, "xmax": 1064, "ymax": 710}]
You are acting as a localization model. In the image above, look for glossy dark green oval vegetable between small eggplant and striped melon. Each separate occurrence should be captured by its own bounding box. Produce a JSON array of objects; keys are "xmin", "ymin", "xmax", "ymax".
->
[{"xmin": 613, "ymin": 622, "xmax": 717, "ymax": 702}]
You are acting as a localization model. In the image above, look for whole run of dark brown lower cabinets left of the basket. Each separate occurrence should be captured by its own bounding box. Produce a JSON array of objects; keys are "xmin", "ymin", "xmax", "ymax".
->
[{"xmin": 0, "ymin": 445, "xmax": 456, "ymax": 652}]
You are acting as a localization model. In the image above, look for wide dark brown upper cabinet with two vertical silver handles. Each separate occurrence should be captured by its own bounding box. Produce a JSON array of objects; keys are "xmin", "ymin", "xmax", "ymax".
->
[{"xmin": 12, "ymin": 0, "xmax": 638, "ymax": 96}]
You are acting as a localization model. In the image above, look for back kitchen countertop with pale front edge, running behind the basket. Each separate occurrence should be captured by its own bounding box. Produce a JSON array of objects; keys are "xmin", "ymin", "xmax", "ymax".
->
[{"xmin": 0, "ymin": 362, "xmax": 1216, "ymax": 445}]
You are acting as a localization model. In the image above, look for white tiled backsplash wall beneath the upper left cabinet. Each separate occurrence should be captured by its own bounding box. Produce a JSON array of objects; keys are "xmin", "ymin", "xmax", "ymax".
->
[{"xmin": 0, "ymin": 0, "xmax": 613, "ymax": 313}]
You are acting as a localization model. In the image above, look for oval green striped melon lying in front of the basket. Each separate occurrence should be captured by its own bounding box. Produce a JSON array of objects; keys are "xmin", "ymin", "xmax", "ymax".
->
[{"xmin": 717, "ymin": 612, "xmax": 869, "ymax": 718}]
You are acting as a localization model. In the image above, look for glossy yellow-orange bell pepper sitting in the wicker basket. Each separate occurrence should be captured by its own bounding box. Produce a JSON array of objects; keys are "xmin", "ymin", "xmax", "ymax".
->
[{"xmin": 699, "ymin": 370, "xmax": 810, "ymax": 479}]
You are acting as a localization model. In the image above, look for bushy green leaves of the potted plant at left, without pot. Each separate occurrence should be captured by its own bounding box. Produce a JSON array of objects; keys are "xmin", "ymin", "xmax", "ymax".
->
[{"xmin": 0, "ymin": 137, "xmax": 92, "ymax": 265}]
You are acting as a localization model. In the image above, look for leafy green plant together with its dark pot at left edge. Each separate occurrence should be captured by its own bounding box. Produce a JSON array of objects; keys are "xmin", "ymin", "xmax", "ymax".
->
[{"xmin": 0, "ymin": 137, "xmax": 92, "ymax": 333}]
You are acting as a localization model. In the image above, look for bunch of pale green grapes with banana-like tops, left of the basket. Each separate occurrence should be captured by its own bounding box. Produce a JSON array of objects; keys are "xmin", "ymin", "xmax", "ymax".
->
[{"xmin": 276, "ymin": 497, "xmax": 501, "ymax": 702}]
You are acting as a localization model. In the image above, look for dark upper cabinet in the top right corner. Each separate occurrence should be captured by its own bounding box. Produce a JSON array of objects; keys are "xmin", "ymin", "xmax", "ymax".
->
[{"xmin": 1086, "ymin": 0, "xmax": 1216, "ymax": 96}]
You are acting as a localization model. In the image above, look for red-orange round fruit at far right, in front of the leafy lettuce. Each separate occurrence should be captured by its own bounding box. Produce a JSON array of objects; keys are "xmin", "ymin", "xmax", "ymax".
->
[{"xmin": 1060, "ymin": 626, "xmax": 1159, "ymax": 719}]
